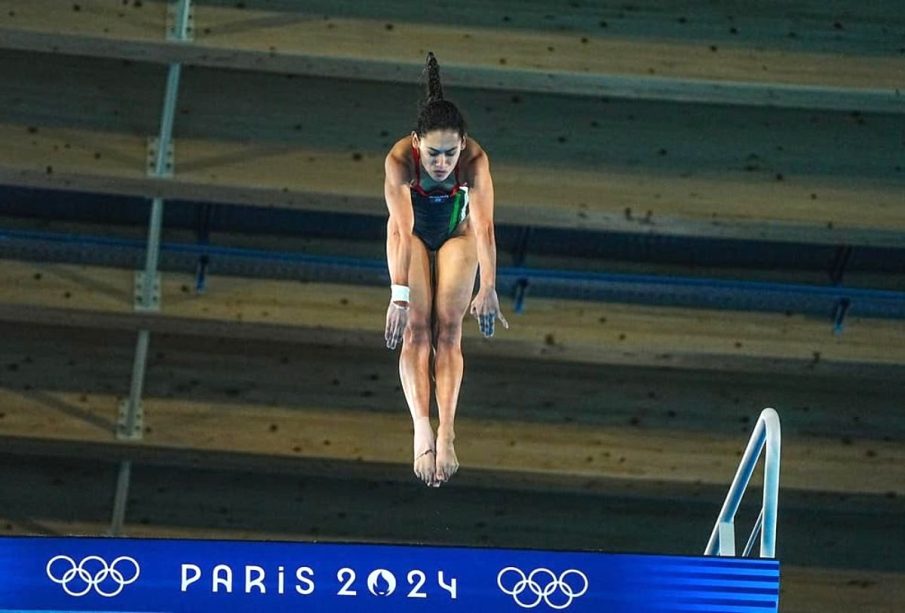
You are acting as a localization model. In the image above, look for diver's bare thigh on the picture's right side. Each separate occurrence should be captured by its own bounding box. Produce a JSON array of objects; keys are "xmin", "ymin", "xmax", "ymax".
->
[{"xmin": 434, "ymin": 221, "xmax": 478, "ymax": 325}]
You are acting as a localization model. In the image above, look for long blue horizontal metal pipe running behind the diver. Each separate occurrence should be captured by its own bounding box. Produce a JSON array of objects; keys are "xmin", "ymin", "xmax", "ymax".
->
[{"xmin": 0, "ymin": 230, "xmax": 905, "ymax": 319}]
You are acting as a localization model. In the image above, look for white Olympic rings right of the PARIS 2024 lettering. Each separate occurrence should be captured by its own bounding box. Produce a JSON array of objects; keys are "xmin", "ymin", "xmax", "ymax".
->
[{"xmin": 497, "ymin": 566, "xmax": 588, "ymax": 609}]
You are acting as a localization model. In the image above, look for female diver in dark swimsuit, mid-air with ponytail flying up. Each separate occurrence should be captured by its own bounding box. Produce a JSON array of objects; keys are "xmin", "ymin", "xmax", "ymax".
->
[{"xmin": 384, "ymin": 53, "xmax": 509, "ymax": 487}]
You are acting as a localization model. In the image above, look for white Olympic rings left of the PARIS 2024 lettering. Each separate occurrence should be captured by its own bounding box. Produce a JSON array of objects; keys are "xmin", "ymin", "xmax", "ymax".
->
[{"xmin": 46, "ymin": 556, "xmax": 141, "ymax": 598}]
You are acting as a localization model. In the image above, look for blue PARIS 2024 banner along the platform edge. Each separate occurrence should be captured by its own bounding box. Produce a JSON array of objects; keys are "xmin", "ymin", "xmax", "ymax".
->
[{"xmin": 0, "ymin": 537, "xmax": 779, "ymax": 613}]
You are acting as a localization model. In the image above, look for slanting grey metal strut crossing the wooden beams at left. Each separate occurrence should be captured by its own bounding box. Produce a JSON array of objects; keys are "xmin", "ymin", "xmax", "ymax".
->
[{"xmin": 110, "ymin": 0, "xmax": 191, "ymax": 536}]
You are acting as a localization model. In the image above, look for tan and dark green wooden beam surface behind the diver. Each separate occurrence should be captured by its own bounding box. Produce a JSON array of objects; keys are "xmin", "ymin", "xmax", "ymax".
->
[{"xmin": 0, "ymin": 0, "xmax": 905, "ymax": 613}]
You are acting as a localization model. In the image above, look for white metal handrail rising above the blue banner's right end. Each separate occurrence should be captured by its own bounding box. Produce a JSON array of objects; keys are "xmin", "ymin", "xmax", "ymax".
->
[{"xmin": 704, "ymin": 408, "xmax": 781, "ymax": 558}]
